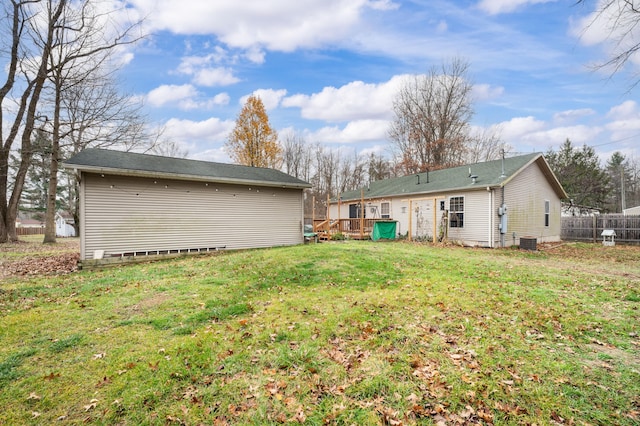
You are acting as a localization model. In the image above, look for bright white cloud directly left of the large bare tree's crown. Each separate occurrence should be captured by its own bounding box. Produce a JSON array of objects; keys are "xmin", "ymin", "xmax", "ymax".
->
[{"xmin": 282, "ymin": 75, "xmax": 406, "ymax": 122}]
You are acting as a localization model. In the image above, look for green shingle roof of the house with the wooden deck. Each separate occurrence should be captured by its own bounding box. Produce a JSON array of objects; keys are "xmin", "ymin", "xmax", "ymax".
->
[{"xmin": 340, "ymin": 153, "xmax": 567, "ymax": 201}]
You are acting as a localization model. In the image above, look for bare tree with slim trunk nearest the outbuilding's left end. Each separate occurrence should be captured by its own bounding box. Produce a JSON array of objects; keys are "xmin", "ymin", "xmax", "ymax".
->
[{"xmin": 35, "ymin": 0, "xmax": 139, "ymax": 243}]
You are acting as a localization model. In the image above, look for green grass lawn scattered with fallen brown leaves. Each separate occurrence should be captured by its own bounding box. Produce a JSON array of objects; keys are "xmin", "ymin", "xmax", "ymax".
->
[{"xmin": 0, "ymin": 241, "xmax": 640, "ymax": 425}]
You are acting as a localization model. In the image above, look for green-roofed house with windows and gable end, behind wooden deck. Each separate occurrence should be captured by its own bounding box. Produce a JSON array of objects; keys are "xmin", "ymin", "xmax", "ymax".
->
[{"xmin": 329, "ymin": 153, "xmax": 567, "ymax": 247}]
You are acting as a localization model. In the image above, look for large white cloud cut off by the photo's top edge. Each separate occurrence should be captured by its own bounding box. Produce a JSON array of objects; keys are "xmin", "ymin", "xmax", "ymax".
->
[{"xmin": 132, "ymin": 0, "xmax": 380, "ymax": 52}]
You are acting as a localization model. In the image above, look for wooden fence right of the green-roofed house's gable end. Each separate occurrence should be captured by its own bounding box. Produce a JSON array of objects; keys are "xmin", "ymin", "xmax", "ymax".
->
[{"xmin": 561, "ymin": 214, "xmax": 640, "ymax": 244}]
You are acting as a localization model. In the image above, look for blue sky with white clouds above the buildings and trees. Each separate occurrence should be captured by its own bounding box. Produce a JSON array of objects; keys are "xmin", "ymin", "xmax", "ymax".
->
[{"xmin": 117, "ymin": 0, "xmax": 640, "ymax": 162}]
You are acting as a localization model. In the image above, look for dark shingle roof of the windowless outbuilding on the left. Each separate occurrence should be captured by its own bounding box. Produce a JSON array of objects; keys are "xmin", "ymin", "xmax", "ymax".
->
[{"xmin": 62, "ymin": 148, "xmax": 311, "ymax": 188}]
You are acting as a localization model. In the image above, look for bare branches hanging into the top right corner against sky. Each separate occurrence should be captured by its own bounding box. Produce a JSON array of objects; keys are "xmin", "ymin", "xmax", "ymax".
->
[{"xmin": 576, "ymin": 0, "xmax": 640, "ymax": 88}]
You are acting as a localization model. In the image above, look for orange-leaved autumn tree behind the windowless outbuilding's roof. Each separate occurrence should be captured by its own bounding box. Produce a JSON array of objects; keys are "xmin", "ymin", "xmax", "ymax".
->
[{"xmin": 225, "ymin": 95, "xmax": 282, "ymax": 168}]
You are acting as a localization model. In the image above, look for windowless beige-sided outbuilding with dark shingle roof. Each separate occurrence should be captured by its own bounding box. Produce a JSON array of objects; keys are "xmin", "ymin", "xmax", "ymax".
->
[{"xmin": 62, "ymin": 149, "xmax": 311, "ymax": 261}]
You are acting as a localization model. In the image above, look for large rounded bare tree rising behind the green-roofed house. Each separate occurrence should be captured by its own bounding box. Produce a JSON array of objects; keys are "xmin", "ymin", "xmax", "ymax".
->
[{"xmin": 389, "ymin": 58, "xmax": 473, "ymax": 174}]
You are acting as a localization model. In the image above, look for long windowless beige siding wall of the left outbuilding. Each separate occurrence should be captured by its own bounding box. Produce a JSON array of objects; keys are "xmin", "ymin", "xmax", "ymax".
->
[{"xmin": 81, "ymin": 173, "xmax": 303, "ymax": 259}]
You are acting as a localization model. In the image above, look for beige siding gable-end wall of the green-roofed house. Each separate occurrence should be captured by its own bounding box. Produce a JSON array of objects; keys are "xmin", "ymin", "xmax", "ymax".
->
[{"xmin": 505, "ymin": 164, "xmax": 561, "ymax": 245}]
